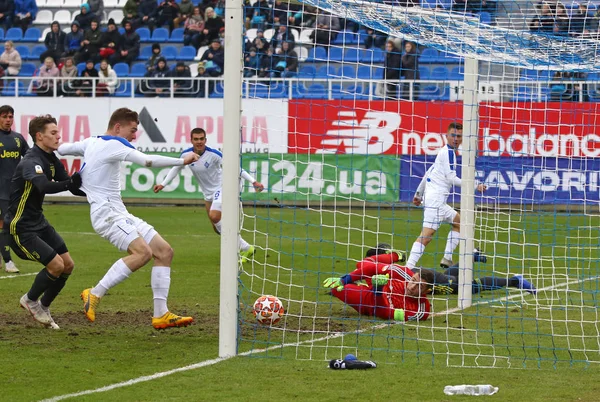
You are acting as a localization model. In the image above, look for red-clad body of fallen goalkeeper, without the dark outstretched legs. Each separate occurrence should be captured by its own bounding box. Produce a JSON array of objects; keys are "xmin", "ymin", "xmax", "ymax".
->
[{"xmin": 323, "ymin": 245, "xmax": 434, "ymax": 321}]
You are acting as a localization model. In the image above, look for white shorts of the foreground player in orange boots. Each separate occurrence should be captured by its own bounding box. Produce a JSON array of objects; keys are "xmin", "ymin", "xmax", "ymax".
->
[{"xmin": 91, "ymin": 204, "xmax": 158, "ymax": 251}]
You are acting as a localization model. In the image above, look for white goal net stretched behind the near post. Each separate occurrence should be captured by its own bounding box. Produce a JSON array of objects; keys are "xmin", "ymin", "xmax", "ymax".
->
[{"xmin": 232, "ymin": 0, "xmax": 600, "ymax": 368}]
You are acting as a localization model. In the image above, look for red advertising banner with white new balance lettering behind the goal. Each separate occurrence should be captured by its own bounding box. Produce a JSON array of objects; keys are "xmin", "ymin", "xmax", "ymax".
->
[{"xmin": 288, "ymin": 100, "xmax": 600, "ymax": 157}]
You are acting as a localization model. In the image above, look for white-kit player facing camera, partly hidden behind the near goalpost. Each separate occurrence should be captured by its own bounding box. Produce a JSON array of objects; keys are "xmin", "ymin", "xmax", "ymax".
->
[{"xmin": 154, "ymin": 128, "xmax": 265, "ymax": 263}]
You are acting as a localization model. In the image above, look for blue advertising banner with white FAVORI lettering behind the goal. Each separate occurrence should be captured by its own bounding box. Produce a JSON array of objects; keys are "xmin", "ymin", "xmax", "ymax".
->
[{"xmin": 400, "ymin": 156, "xmax": 600, "ymax": 204}]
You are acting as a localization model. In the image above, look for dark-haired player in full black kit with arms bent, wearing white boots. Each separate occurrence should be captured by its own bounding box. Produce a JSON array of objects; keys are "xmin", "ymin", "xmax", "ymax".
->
[{"xmin": 4, "ymin": 115, "xmax": 85, "ymax": 329}]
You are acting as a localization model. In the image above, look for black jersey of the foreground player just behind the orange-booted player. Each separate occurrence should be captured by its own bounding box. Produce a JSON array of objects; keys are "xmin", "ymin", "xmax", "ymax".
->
[{"xmin": 4, "ymin": 145, "xmax": 69, "ymax": 234}]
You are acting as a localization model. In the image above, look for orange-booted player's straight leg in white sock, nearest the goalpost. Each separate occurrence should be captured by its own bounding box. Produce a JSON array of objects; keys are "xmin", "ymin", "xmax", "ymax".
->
[{"xmin": 147, "ymin": 229, "xmax": 194, "ymax": 329}]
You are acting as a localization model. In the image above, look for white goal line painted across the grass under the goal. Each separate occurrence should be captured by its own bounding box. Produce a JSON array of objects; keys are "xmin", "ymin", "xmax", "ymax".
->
[{"xmin": 41, "ymin": 275, "xmax": 600, "ymax": 402}]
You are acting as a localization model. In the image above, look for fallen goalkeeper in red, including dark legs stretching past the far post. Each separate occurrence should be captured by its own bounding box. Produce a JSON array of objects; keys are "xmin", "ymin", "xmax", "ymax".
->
[{"xmin": 323, "ymin": 244, "xmax": 536, "ymax": 321}]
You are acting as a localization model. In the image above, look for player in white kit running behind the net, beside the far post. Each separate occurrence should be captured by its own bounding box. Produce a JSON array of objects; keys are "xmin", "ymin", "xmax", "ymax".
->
[{"xmin": 406, "ymin": 123, "xmax": 487, "ymax": 268}]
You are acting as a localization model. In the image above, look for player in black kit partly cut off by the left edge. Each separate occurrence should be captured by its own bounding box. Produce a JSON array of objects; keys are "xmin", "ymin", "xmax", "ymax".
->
[{"xmin": 0, "ymin": 105, "xmax": 29, "ymax": 274}]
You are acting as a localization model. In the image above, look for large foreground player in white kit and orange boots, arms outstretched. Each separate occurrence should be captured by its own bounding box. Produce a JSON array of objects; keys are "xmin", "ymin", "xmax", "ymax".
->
[{"xmin": 58, "ymin": 108, "xmax": 198, "ymax": 329}]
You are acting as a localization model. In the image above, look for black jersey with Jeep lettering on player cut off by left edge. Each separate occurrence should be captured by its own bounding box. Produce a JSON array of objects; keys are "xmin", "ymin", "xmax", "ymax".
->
[{"xmin": 0, "ymin": 130, "xmax": 29, "ymax": 201}]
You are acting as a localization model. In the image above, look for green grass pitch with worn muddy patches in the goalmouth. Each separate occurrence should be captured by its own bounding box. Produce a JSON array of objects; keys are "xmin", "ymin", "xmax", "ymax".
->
[{"xmin": 0, "ymin": 205, "xmax": 600, "ymax": 401}]
